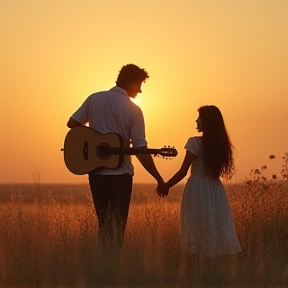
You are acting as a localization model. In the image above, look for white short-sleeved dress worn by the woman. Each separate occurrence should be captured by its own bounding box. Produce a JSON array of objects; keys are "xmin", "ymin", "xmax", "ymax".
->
[{"xmin": 179, "ymin": 137, "xmax": 241, "ymax": 256}]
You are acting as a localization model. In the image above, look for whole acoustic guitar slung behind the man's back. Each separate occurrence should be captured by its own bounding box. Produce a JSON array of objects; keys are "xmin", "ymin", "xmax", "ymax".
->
[{"xmin": 61, "ymin": 126, "xmax": 177, "ymax": 175}]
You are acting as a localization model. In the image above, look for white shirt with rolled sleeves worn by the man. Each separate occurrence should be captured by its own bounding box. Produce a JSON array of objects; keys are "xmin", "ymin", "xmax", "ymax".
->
[{"xmin": 71, "ymin": 86, "xmax": 147, "ymax": 175}]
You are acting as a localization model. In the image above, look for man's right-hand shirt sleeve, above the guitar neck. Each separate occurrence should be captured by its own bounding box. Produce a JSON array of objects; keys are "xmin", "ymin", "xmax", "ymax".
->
[{"xmin": 130, "ymin": 109, "xmax": 147, "ymax": 147}]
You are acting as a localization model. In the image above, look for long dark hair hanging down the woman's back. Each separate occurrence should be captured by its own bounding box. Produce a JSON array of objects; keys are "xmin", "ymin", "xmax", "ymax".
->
[{"xmin": 198, "ymin": 105, "xmax": 234, "ymax": 179}]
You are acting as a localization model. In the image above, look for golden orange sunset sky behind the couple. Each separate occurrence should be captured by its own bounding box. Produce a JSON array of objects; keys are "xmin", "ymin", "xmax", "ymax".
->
[{"xmin": 0, "ymin": 0, "xmax": 288, "ymax": 184}]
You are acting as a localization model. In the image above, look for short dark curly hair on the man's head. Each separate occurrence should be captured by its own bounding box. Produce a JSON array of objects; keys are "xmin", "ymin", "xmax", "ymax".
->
[{"xmin": 116, "ymin": 64, "xmax": 149, "ymax": 89}]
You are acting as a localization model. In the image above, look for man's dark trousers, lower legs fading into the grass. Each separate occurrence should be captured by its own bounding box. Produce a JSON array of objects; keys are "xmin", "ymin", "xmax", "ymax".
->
[{"xmin": 89, "ymin": 174, "xmax": 132, "ymax": 249}]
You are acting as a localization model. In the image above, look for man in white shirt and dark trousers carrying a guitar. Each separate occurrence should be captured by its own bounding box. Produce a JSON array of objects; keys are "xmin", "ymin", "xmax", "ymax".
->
[{"xmin": 67, "ymin": 64, "xmax": 164, "ymax": 248}]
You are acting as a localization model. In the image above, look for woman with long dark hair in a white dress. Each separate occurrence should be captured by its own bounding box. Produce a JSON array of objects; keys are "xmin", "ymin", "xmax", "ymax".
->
[{"xmin": 157, "ymin": 106, "xmax": 241, "ymax": 256}]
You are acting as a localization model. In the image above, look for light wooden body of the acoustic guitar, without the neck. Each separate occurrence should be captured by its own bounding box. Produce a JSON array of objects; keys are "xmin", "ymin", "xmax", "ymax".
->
[{"xmin": 63, "ymin": 126, "xmax": 123, "ymax": 175}]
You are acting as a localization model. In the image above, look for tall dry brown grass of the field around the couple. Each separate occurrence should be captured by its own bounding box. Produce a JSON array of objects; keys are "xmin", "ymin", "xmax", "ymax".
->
[{"xmin": 0, "ymin": 158, "xmax": 288, "ymax": 288}]
